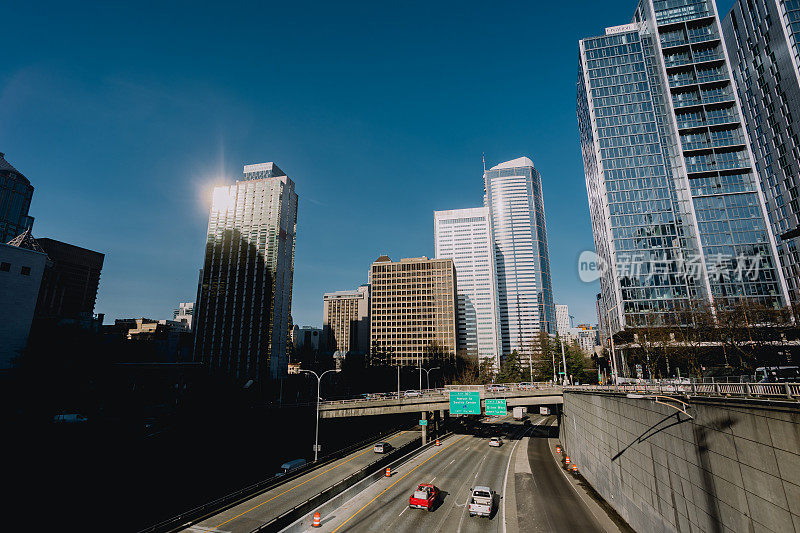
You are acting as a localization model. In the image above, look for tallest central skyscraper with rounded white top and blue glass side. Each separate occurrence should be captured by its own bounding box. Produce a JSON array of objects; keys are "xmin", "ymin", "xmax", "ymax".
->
[{"xmin": 483, "ymin": 157, "xmax": 556, "ymax": 356}]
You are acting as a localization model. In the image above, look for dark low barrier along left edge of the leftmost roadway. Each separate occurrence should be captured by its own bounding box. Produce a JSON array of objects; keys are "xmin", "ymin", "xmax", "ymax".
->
[{"xmin": 139, "ymin": 422, "xmax": 414, "ymax": 533}]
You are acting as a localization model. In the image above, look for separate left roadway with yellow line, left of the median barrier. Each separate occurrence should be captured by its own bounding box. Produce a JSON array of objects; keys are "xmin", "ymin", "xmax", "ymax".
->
[{"xmin": 184, "ymin": 431, "xmax": 420, "ymax": 533}]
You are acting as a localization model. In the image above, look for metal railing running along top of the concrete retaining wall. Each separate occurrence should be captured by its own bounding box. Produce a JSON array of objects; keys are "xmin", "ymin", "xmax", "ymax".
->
[{"xmin": 565, "ymin": 383, "xmax": 800, "ymax": 401}]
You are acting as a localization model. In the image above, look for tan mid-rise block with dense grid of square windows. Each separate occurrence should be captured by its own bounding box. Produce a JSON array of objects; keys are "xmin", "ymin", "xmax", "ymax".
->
[{"xmin": 370, "ymin": 255, "xmax": 457, "ymax": 366}]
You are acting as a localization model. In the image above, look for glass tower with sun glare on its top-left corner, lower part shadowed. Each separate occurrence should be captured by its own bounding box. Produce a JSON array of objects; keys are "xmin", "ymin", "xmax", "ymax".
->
[{"xmin": 194, "ymin": 163, "xmax": 298, "ymax": 384}]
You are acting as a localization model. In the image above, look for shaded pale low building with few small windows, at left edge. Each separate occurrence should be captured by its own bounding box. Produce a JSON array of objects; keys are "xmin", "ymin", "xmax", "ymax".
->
[{"xmin": 0, "ymin": 235, "xmax": 47, "ymax": 370}]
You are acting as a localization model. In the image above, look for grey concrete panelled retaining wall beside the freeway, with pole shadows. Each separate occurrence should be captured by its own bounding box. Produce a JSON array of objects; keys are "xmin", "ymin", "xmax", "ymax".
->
[{"xmin": 560, "ymin": 392, "xmax": 800, "ymax": 533}]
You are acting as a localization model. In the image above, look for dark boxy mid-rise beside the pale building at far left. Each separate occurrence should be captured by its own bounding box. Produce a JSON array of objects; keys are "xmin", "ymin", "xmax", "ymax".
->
[{"xmin": 36, "ymin": 238, "xmax": 105, "ymax": 321}]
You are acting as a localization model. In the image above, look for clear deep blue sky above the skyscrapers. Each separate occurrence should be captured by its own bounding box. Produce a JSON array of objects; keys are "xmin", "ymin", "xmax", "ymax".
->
[{"xmin": 0, "ymin": 1, "xmax": 730, "ymax": 325}]
